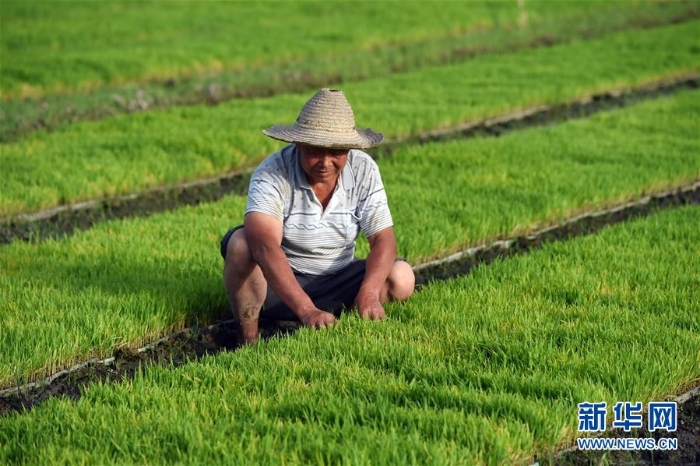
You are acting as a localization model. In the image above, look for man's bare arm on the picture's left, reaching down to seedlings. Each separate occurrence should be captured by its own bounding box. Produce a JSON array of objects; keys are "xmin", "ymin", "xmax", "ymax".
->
[{"xmin": 243, "ymin": 212, "xmax": 335, "ymax": 327}]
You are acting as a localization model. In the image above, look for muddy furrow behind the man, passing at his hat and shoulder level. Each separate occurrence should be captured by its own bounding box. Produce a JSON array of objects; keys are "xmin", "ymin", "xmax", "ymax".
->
[{"xmin": 0, "ymin": 74, "xmax": 700, "ymax": 244}]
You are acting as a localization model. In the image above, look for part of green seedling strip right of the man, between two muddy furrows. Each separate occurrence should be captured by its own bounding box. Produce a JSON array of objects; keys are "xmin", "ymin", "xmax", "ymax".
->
[{"xmin": 382, "ymin": 91, "xmax": 700, "ymax": 261}]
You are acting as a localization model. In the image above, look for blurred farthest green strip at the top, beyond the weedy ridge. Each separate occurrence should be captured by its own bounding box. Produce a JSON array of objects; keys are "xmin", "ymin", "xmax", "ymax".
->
[{"xmin": 0, "ymin": 0, "xmax": 690, "ymax": 98}]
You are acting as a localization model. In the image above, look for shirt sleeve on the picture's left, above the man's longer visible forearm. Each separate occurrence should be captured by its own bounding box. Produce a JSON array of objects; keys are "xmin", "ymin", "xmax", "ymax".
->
[{"xmin": 245, "ymin": 152, "xmax": 289, "ymax": 222}]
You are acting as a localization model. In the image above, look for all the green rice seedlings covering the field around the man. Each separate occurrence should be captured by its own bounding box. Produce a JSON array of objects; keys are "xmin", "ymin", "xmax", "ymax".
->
[{"xmin": 0, "ymin": 1, "xmax": 700, "ymax": 464}]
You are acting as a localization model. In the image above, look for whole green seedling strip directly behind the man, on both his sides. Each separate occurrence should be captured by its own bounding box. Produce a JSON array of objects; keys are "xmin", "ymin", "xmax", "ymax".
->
[{"xmin": 0, "ymin": 87, "xmax": 700, "ymax": 387}]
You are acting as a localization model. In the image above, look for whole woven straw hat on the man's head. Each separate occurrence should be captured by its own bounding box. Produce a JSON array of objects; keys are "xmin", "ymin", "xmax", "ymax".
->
[{"xmin": 263, "ymin": 88, "xmax": 384, "ymax": 149}]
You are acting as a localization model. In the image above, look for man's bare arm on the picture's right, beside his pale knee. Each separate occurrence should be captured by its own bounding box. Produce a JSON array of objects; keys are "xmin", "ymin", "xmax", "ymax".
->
[{"xmin": 355, "ymin": 227, "xmax": 396, "ymax": 320}]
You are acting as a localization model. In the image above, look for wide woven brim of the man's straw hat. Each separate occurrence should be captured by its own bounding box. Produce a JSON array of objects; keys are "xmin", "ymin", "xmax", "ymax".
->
[{"xmin": 263, "ymin": 125, "xmax": 384, "ymax": 149}]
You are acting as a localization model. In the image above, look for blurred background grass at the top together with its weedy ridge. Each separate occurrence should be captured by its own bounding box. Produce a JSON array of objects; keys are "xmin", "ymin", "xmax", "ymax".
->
[{"xmin": 0, "ymin": 0, "xmax": 700, "ymax": 142}]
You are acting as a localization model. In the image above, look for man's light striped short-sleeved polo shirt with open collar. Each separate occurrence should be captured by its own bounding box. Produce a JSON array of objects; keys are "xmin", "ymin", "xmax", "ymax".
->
[{"xmin": 246, "ymin": 144, "xmax": 393, "ymax": 275}]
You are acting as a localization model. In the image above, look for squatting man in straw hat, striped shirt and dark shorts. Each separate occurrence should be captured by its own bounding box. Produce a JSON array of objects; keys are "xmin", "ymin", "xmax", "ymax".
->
[{"xmin": 221, "ymin": 89, "xmax": 415, "ymax": 344}]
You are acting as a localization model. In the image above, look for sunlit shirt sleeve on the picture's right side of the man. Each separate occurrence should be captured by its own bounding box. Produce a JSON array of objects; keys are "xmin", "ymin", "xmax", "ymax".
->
[{"xmin": 357, "ymin": 156, "xmax": 394, "ymax": 238}]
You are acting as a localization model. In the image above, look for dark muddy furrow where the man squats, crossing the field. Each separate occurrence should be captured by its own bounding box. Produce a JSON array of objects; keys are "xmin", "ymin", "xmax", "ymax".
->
[{"xmin": 0, "ymin": 181, "xmax": 700, "ymax": 416}]
